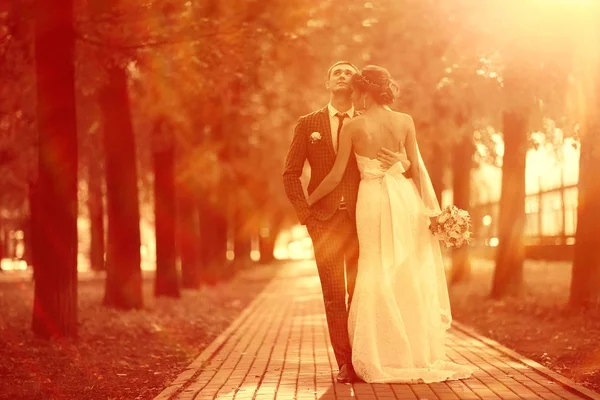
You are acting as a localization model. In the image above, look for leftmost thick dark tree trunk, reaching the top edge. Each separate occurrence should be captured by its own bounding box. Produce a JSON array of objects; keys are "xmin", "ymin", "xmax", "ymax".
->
[{"xmin": 32, "ymin": 0, "xmax": 77, "ymax": 338}]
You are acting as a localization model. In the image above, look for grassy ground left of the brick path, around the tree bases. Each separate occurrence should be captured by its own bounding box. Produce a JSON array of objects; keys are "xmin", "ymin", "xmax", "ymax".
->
[{"xmin": 0, "ymin": 264, "xmax": 279, "ymax": 400}]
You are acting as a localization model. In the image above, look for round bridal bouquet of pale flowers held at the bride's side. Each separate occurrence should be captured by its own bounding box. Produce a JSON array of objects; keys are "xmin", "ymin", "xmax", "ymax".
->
[{"xmin": 429, "ymin": 206, "xmax": 472, "ymax": 247}]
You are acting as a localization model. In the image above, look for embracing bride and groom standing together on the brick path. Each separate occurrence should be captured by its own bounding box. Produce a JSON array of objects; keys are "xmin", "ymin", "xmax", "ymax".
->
[{"xmin": 283, "ymin": 61, "xmax": 472, "ymax": 383}]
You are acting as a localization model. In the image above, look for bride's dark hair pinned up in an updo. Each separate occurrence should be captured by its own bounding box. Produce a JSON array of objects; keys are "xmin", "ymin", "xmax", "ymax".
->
[{"xmin": 351, "ymin": 65, "xmax": 398, "ymax": 105}]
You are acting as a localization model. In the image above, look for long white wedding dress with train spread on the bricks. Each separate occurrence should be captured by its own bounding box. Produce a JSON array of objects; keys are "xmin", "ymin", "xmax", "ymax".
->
[{"xmin": 348, "ymin": 154, "xmax": 473, "ymax": 383}]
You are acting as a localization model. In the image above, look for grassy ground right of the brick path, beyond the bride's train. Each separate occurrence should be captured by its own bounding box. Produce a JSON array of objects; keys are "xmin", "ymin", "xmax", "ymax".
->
[{"xmin": 450, "ymin": 259, "xmax": 600, "ymax": 392}]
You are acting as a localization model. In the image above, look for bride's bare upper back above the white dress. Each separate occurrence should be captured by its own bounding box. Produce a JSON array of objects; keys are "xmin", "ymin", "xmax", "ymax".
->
[{"xmin": 352, "ymin": 108, "xmax": 410, "ymax": 158}]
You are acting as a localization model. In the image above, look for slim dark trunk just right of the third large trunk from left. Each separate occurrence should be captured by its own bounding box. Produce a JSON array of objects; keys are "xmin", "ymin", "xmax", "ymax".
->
[{"xmin": 177, "ymin": 191, "xmax": 200, "ymax": 289}]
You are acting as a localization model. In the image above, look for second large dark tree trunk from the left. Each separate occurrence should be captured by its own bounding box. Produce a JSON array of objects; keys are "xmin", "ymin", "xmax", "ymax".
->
[{"xmin": 99, "ymin": 67, "xmax": 143, "ymax": 309}]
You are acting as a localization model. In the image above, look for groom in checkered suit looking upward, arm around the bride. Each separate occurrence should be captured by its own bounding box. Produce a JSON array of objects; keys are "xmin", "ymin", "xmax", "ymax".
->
[{"xmin": 283, "ymin": 61, "xmax": 405, "ymax": 383}]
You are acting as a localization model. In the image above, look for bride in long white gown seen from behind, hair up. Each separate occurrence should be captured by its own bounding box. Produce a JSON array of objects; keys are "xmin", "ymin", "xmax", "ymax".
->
[{"xmin": 308, "ymin": 66, "xmax": 473, "ymax": 383}]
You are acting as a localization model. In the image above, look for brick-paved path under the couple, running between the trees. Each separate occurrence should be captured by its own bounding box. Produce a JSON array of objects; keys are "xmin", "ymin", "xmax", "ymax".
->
[{"xmin": 155, "ymin": 261, "xmax": 600, "ymax": 400}]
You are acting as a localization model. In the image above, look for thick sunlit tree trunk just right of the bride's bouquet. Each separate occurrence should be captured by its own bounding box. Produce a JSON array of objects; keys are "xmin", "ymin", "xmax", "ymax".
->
[{"xmin": 491, "ymin": 111, "xmax": 528, "ymax": 298}]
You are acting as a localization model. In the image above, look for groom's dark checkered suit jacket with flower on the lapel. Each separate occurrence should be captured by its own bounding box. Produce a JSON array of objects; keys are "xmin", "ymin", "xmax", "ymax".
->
[{"xmin": 283, "ymin": 107, "xmax": 360, "ymax": 224}]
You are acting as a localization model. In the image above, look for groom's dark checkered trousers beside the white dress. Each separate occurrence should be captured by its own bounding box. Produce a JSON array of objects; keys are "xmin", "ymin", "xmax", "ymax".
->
[{"xmin": 307, "ymin": 210, "xmax": 358, "ymax": 367}]
